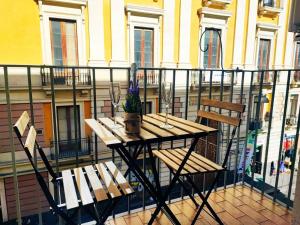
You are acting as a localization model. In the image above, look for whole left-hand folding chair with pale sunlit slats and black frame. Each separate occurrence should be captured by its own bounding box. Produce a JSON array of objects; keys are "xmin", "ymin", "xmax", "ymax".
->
[{"xmin": 14, "ymin": 111, "xmax": 133, "ymax": 225}]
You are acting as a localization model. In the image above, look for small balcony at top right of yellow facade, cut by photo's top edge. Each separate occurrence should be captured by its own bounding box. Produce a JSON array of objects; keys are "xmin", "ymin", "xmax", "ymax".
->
[{"xmin": 258, "ymin": 0, "xmax": 282, "ymax": 17}]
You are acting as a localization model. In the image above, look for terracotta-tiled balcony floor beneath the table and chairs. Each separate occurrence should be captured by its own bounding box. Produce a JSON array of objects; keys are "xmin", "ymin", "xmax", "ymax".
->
[{"xmin": 107, "ymin": 186, "xmax": 292, "ymax": 225}]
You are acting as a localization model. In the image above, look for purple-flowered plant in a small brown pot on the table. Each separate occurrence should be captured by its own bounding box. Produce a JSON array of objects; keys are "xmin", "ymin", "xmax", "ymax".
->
[{"xmin": 123, "ymin": 81, "xmax": 142, "ymax": 134}]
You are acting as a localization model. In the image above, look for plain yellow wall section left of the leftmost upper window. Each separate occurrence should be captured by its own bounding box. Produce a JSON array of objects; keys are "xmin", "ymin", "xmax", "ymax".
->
[{"xmin": 0, "ymin": 0, "xmax": 42, "ymax": 64}]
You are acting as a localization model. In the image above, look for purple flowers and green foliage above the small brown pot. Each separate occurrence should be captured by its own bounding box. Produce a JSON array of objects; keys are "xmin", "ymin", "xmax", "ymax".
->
[{"xmin": 123, "ymin": 81, "xmax": 142, "ymax": 114}]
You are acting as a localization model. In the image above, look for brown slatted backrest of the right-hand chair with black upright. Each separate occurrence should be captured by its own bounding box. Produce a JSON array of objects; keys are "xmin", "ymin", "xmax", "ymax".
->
[{"xmin": 197, "ymin": 99, "xmax": 245, "ymax": 167}]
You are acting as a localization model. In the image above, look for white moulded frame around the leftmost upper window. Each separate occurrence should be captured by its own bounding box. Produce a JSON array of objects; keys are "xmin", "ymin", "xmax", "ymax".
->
[{"xmin": 39, "ymin": 1, "xmax": 86, "ymax": 66}]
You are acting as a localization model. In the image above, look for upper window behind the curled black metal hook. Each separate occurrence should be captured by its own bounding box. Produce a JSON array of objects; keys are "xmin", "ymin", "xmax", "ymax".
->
[{"xmin": 203, "ymin": 30, "xmax": 221, "ymax": 68}]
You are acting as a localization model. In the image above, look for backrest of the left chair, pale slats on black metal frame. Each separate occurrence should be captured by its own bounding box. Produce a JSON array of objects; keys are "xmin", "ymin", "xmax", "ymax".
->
[{"xmin": 14, "ymin": 111, "xmax": 76, "ymax": 225}]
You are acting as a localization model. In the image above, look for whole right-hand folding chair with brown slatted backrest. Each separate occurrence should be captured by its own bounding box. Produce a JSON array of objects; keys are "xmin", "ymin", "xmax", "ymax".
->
[{"xmin": 153, "ymin": 99, "xmax": 245, "ymax": 224}]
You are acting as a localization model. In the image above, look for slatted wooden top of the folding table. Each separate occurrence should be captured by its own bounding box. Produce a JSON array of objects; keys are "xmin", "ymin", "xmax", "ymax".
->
[{"xmin": 85, "ymin": 113, "xmax": 217, "ymax": 147}]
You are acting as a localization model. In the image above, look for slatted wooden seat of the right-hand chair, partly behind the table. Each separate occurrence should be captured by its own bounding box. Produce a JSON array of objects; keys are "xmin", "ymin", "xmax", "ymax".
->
[{"xmin": 153, "ymin": 148, "xmax": 224, "ymax": 175}]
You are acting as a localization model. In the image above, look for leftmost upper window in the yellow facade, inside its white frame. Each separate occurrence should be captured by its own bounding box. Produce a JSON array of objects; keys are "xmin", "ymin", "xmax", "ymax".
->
[{"xmin": 50, "ymin": 19, "xmax": 78, "ymax": 66}]
